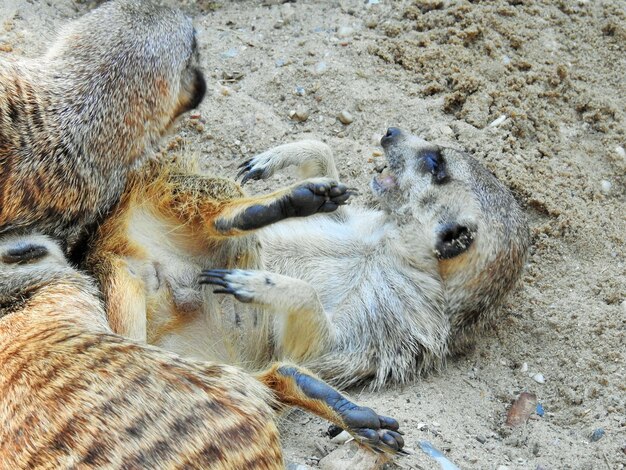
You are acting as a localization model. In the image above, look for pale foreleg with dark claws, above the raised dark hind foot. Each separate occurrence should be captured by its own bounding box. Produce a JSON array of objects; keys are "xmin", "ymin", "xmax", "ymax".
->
[{"xmin": 237, "ymin": 140, "xmax": 339, "ymax": 185}]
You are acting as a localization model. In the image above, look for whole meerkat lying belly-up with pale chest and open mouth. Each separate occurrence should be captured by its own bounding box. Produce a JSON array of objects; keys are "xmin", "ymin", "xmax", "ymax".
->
[{"xmin": 80, "ymin": 129, "xmax": 529, "ymax": 387}]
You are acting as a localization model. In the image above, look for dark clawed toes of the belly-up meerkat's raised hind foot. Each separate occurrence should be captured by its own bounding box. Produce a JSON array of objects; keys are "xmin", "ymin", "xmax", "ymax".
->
[{"xmin": 285, "ymin": 178, "xmax": 355, "ymax": 217}]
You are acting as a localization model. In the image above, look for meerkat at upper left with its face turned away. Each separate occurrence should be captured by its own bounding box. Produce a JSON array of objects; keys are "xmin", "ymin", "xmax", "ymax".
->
[{"xmin": 0, "ymin": 0, "xmax": 206, "ymax": 252}]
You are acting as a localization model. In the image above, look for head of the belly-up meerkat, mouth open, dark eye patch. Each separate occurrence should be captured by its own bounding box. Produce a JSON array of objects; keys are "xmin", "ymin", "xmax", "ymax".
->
[{"xmin": 371, "ymin": 128, "xmax": 529, "ymax": 346}]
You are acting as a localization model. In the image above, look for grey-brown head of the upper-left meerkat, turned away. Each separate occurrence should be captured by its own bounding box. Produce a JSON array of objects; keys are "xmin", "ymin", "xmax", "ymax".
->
[{"xmin": 46, "ymin": 0, "xmax": 206, "ymax": 167}]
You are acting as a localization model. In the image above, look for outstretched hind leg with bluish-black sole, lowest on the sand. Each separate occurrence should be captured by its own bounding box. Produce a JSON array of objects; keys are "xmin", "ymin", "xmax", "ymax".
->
[{"xmin": 257, "ymin": 364, "xmax": 404, "ymax": 453}]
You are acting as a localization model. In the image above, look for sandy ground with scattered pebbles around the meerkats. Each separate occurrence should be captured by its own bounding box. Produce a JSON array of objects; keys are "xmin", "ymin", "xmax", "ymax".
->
[{"xmin": 0, "ymin": 0, "xmax": 626, "ymax": 469}]
